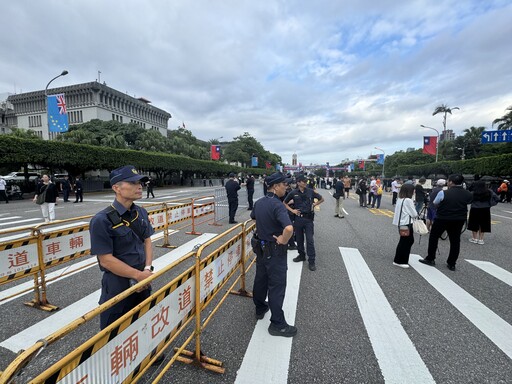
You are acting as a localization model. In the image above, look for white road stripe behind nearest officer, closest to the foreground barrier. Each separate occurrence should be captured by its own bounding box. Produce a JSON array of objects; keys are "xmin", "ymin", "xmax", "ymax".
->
[{"xmin": 0, "ymin": 233, "xmax": 217, "ymax": 352}]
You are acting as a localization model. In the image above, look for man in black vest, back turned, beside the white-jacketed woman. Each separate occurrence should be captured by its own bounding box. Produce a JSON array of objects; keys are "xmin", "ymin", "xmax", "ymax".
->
[{"xmin": 420, "ymin": 175, "xmax": 473, "ymax": 271}]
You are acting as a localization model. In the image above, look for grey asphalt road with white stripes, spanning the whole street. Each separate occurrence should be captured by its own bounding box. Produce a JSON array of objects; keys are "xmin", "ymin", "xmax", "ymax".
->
[{"xmin": 0, "ymin": 187, "xmax": 512, "ymax": 384}]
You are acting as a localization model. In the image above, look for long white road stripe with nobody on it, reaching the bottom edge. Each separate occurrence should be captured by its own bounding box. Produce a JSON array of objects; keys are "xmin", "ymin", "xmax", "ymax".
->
[{"xmin": 340, "ymin": 247, "xmax": 435, "ymax": 383}]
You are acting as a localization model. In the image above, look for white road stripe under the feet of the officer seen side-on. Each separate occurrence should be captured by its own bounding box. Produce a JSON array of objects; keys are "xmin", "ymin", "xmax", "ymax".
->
[{"xmin": 235, "ymin": 251, "xmax": 303, "ymax": 384}]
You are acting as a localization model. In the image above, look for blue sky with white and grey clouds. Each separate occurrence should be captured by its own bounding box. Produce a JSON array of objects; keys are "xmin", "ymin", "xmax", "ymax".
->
[{"xmin": 0, "ymin": 0, "xmax": 512, "ymax": 165}]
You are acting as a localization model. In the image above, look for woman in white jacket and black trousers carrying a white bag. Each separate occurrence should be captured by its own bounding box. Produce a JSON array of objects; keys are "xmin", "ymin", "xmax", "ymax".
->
[{"xmin": 393, "ymin": 184, "xmax": 418, "ymax": 268}]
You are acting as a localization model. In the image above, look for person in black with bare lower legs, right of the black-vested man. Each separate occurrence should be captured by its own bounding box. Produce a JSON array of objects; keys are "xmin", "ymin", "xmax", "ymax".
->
[{"xmin": 468, "ymin": 180, "xmax": 500, "ymax": 245}]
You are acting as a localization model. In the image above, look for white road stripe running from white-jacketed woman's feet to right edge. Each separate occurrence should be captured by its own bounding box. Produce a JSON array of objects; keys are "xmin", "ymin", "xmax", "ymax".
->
[{"xmin": 409, "ymin": 254, "xmax": 512, "ymax": 358}]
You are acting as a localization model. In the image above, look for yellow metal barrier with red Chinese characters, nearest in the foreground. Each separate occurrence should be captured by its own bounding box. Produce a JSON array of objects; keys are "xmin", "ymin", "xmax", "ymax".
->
[{"xmin": 0, "ymin": 222, "xmax": 254, "ymax": 383}]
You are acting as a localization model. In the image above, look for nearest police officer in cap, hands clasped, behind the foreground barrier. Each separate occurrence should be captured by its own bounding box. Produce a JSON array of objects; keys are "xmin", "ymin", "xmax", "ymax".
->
[{"xmin": 89, "ymin": 165, "xmax": 154, "ymax": 329}]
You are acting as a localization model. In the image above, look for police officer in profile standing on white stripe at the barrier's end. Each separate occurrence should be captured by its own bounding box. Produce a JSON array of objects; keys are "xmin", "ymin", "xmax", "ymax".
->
[{"xmin": 251, "ymin": 173, "xmax": 297, "ymax": 337}]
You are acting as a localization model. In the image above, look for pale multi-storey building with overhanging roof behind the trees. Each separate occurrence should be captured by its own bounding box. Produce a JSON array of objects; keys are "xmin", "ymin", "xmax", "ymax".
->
[{"xmin": 5, "ymin": 81, "xmax": 172, "ymax": 140}]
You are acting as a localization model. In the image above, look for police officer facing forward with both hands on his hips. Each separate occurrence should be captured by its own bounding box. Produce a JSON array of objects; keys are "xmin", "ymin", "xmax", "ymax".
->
[{"xmin": 284, "ymin": 175, "xmax": 324, "ymax": 271}]
